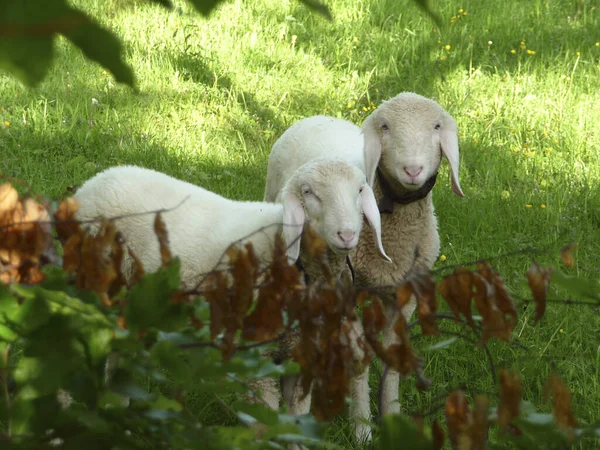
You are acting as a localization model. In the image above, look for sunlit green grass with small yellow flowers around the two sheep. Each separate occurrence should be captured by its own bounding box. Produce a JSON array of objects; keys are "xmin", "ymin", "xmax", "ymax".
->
[{"xmin": 0, "ymin": 0, "xmax": 600, "ymax": 448}]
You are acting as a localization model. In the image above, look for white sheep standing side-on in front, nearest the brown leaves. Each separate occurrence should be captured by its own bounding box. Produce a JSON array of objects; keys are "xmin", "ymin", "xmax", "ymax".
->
[{"xmin": 75, "ymin": 160, "xmax": 384, "ymax": 286}]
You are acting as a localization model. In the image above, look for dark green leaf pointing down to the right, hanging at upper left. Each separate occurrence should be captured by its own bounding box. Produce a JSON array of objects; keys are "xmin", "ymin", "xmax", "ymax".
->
[{"xmin": 62, "ymin": 9, "xmax": 135, "ymax": 87}]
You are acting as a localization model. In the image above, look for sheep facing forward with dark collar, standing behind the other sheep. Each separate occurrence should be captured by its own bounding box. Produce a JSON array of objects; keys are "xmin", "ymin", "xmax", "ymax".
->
[{"xmin": 265, "ymin": 92, "xmax": 463, "ymax": 440}]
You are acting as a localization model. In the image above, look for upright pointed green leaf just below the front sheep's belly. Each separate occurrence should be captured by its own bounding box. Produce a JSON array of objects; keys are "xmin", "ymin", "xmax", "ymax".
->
[{"xmin": 125, "ymin": 258, "xmax": 187, "ymax": 332}]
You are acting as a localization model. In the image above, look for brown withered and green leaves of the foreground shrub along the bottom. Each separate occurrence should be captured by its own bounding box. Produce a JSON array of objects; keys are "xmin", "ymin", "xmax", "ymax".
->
[{"xmin": 0, "ymin": 183, "xmax": 600, "ymax": 449}]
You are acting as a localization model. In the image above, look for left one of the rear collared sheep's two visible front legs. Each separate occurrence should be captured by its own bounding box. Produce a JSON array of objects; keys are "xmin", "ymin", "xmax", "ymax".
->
[{"xmin": 348, "ymin": 320, "xmax": 371, "ymax": 442}]
